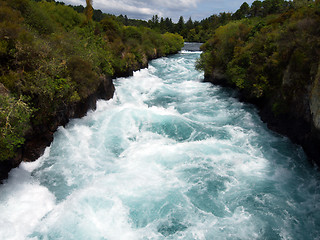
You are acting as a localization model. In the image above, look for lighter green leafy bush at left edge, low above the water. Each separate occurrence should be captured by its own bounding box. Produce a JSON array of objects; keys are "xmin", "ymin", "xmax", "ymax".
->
[{"xmin": 0, "ymin": 94, "xmax": 31, "ymax": 161}]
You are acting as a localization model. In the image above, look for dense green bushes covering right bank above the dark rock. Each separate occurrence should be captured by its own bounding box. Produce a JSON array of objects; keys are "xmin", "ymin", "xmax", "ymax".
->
[{"xmin": 198, "ymin": 1, "xmax": 320, "ymax": 115}]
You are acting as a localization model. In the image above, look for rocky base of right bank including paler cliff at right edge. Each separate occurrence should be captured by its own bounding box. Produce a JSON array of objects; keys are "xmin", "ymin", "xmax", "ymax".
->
[{"xmin": 204, "ymin": 65, "xmax": 320, "ymax": 166}]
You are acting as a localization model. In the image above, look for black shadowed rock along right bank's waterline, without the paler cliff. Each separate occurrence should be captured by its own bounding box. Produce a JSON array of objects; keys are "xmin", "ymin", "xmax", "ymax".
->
[{"xmin": 204, "ymin": 74, "xmax": 320, "ymax": 166}]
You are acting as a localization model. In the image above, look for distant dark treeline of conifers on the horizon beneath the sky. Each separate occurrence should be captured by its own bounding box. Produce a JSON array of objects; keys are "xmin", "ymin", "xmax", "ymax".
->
[{"xmin": 54, "ymin": 0, "xmax": 312, "ymax": 42}]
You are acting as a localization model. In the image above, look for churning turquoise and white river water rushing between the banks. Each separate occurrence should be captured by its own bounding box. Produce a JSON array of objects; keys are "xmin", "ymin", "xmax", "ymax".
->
[{"xmin": 0, "ymin": 52, "xmax": 320, "ymax": 240}]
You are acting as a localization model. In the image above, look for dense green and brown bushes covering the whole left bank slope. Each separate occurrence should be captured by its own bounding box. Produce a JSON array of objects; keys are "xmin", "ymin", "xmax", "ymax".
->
[{"xmin": 0, "ymin": 0, "xmax": 183, "ymax": 161}]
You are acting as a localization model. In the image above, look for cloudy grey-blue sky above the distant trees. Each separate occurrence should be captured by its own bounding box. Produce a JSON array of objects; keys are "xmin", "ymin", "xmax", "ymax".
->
[{"xmin": 59, "ymin": 0, "xmax": 253, "ymax": 22}]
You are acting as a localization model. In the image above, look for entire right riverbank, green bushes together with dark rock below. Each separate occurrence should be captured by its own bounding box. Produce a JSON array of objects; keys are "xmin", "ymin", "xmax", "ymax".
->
[{"xmin": 197, "ymin": 2, "xmax": 320, "ymax": 166}]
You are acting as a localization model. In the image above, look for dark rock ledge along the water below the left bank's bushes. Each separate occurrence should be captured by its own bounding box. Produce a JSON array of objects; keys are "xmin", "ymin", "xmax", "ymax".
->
[{"xmin": 0, "ymin": 76, "xmax": 115, "ymax": 181}]
